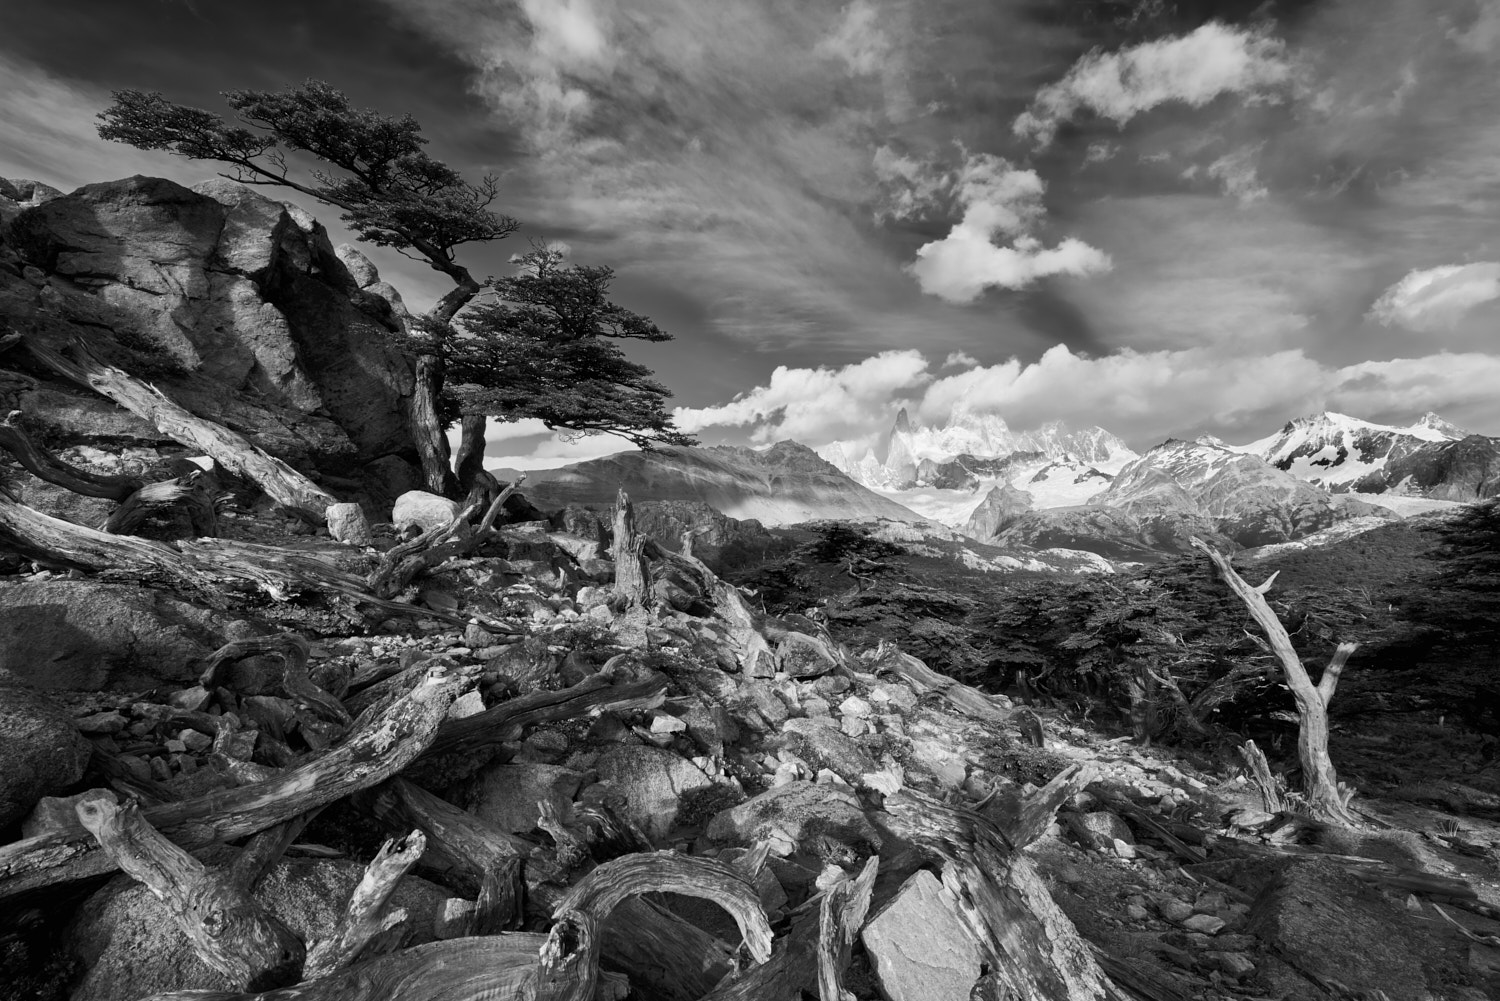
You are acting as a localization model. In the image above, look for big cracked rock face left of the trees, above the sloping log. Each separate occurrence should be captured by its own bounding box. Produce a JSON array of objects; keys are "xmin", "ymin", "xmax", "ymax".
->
[{"xmin": 0, "ymin": 177, "xmax": 413, "ymax": 462}]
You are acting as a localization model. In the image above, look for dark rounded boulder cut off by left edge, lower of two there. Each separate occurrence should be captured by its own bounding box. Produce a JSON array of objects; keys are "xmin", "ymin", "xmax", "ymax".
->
[{"xmin": 0, "ymin": 684, "xmax": 93, "ymax": 831}]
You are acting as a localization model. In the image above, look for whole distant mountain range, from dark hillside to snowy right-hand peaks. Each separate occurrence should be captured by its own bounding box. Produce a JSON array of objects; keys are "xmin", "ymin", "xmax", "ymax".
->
[{"xmin": 507, "ymin": 408, "xmax": 1500, "ymax": 570}]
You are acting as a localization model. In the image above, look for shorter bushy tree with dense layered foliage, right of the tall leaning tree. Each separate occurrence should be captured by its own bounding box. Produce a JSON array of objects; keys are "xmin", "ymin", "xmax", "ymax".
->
[{"xmin": 438, "ymin": 246, "xmax": 695, "ymax": 491}]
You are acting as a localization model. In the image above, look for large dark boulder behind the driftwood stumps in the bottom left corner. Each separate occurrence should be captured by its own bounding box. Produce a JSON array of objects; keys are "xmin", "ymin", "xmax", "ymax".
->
[{"xmin": 66, "ymin": 858, "xmax": 449, "ymax": 1001}]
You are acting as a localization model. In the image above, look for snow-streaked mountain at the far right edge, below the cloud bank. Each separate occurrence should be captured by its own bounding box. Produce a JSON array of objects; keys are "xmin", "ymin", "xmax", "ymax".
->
[{"xmin": 1230, "ymin": 413, "xmax": 1500, "ymax": 501}]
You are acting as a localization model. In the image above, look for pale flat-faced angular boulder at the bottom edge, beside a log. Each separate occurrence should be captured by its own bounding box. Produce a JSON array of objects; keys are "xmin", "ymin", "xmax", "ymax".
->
[{"xmin": 860, "ymin": 869, "xmax": 984, "ymax": 1001}]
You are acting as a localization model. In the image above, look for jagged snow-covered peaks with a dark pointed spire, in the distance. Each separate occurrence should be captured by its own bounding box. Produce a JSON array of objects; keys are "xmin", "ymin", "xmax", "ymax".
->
[{"xmin": 818, "ymin": 405, "xmax": 1137, "ymax": 491}]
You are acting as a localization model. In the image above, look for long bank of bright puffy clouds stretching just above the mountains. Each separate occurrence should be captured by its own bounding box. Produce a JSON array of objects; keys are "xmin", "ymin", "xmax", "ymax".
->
[{"xmin": 677, "ymin": 345, "xmax": 1500, "ymax": 452}]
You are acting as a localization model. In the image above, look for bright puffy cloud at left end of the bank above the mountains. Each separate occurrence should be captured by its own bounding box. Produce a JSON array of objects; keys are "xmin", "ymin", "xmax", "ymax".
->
[{"xmin": 672, "ymin": 351, "xmax": 932, "ymax": 444}]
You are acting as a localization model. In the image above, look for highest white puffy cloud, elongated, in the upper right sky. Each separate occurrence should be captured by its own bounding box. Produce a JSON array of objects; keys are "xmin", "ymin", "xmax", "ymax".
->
[{"xmin": 1013, "ymin": 21, "xmax": 1293, "ymax": 146}]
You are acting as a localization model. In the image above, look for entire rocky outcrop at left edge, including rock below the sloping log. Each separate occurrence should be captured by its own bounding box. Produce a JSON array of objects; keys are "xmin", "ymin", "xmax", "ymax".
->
[{"xmin": 0, "ymin": 177, "xmax": 414, "ymax": 513}]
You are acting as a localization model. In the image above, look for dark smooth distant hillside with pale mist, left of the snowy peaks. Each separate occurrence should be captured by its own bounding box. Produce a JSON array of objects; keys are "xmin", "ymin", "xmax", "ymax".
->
[{"xmin": 527, "ymin": 441, "xmax": 926, "ymax": 525}]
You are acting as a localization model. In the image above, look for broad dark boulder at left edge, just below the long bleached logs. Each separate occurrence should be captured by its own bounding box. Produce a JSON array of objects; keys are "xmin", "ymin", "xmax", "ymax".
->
[{"xmin": 0, "ymin": 581, "xmax": 243, "ymax": 692}]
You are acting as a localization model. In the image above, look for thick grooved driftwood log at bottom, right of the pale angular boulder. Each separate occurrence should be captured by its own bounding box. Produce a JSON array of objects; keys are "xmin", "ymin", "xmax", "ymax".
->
[{"xmin": 882, "ymin": 789, "xmax": 1121, "ymax": 1001}]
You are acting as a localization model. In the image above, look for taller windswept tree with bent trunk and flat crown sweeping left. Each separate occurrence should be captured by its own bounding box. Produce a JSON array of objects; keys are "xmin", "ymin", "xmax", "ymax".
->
[{"xmin": 99, "ymin": 80, "xmax": 521, "ymax": 494}]
